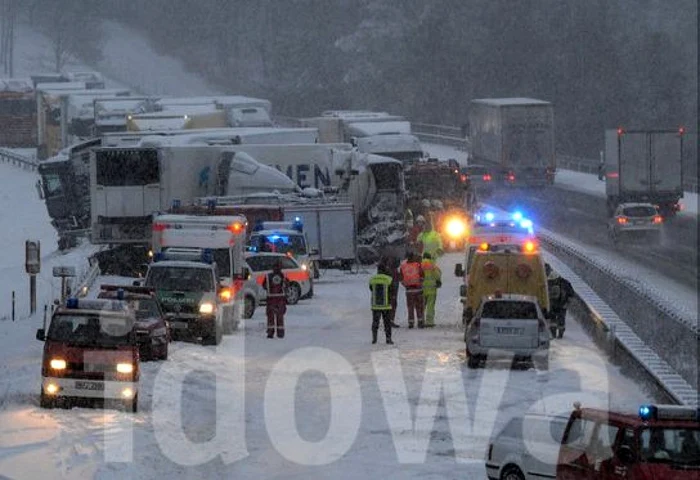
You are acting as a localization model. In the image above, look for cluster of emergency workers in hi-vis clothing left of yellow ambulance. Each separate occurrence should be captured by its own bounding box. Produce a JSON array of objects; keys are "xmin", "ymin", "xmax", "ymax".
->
[{"xmin": 369, "ymin": 215, "xmax": 443, "ymax": 345}]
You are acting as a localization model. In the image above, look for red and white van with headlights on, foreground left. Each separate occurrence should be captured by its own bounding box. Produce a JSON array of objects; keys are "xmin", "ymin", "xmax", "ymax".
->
[{"xmin": 36, "ymin": 298, "xmax": 139, "ymax": 412}]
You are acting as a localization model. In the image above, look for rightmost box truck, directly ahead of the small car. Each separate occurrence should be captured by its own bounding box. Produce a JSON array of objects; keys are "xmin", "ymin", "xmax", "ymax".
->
[{"xmin": 604, "ymin": 127, "xmax": 685, "ymax": 217}]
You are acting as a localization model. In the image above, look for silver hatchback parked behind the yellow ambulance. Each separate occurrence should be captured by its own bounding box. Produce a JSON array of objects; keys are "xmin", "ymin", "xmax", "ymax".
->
[{"xmin": 464, "ymin": 294, "xmax": 551, "ymax": 370}]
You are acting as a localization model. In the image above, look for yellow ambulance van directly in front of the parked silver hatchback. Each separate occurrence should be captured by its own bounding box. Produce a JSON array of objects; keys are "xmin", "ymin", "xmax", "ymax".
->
[{"xmin": 455, "ymin": 245, "xmax": 550, "ymax": 324}]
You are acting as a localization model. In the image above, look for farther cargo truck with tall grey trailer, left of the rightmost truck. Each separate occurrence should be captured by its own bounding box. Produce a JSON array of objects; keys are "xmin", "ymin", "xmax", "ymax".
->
[{"xmin": 469, "ymin": 98, "xmax": 556, "ymax": 187}]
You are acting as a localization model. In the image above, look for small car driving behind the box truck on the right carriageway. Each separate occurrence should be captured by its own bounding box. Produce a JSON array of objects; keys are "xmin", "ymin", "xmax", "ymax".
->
[{"xmin": 608, "ymin": 203, "xmax": 664, "ymax": 243}]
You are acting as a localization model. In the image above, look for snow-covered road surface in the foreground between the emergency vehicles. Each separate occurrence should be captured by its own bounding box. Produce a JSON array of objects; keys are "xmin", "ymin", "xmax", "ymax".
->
[{"xmin": 0, "ymin": 254, "xmax": 648, "ymax": 479}]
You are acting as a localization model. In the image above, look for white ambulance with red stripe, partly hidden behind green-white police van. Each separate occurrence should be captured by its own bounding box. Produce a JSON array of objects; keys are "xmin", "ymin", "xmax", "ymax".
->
[{"xmin": 151, "ymin": 214, "xmax": 258, "ymax": 326}]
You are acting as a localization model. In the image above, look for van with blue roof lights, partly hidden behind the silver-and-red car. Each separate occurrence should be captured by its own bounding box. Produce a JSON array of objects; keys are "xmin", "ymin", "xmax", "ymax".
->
[{"xmin": 248, "ymin": 217, "xmax": 317, "ymax": 297}]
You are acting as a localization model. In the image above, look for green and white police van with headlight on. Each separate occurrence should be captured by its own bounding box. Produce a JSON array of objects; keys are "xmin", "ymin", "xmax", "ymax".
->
[{"xmin": 145, "ymin": 247, "xmax": 227, "ymax": 345}]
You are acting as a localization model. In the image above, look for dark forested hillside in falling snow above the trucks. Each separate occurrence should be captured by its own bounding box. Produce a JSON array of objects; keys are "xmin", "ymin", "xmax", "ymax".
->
[{"xmin": 20, "ymin": 0, "xmax": 698, "ymax": 157}]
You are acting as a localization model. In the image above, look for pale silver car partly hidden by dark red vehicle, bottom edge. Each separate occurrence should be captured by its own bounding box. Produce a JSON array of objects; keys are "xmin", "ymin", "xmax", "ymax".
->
[{"xmin": 486, "ymin": 414, "xmax": 569, "ymax": 480}]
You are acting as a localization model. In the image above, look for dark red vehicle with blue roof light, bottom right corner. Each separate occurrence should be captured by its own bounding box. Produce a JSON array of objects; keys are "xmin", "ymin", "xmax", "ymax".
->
[{"xmin": 557, "ymin": 403, "xmax": 700, "ymax": 480}]
